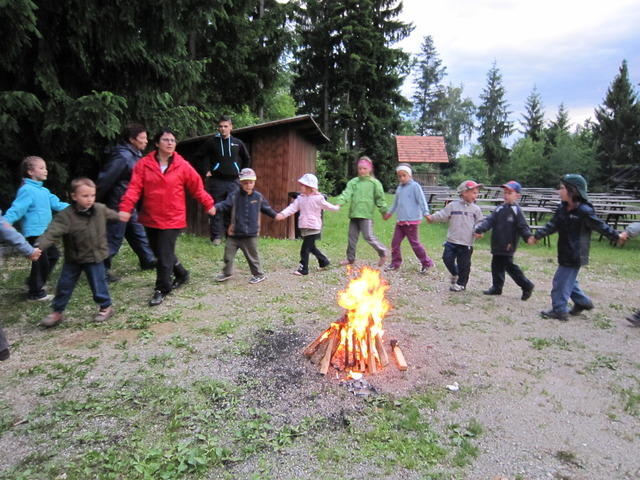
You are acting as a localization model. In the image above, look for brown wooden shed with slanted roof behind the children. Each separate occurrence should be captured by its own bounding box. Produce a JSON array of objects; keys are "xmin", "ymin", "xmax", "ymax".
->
[{"xmin": 178, "ymin": 115, "xmax": 329, "ymax": 238}]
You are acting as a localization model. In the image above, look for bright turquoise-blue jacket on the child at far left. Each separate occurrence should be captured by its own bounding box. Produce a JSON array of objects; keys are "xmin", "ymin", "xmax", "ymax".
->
[{"xmin": 4, "ymin": 178, "xmax": 69, "ymax": 237}]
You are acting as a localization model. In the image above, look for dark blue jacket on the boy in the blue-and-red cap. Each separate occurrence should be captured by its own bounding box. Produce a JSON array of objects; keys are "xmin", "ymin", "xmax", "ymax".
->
[{"xmin": 476, "ymin": 204, "xmax": 531, "ymax": 255}]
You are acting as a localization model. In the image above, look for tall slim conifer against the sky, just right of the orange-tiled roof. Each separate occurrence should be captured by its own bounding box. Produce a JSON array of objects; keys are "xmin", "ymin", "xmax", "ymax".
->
[{"xmin": 476, "ymin": 62, "xmax": 513, "ymax": 172}]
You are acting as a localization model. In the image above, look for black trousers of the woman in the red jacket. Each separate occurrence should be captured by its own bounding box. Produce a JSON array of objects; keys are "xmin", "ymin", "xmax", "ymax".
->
[{"xmin": 145, "ymin": 227, "xmax": 189, "ymax": 294}]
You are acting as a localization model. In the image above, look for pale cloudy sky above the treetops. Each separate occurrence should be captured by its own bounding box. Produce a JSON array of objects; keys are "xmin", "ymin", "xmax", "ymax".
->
[{"xmin": 398, "ymin": 0, "xmax": 640, "ymax": 135}]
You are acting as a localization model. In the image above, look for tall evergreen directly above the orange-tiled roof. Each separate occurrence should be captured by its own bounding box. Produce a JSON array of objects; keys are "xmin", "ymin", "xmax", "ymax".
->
[{"xmin": 413, "ymin": 35, "xmax": 447, "ymax": 135}]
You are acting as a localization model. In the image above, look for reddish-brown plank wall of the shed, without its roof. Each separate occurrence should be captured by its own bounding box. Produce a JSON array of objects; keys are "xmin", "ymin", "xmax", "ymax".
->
[{"xmin": 181, "ymin": 126, "xmax": 317, "ymax": 238}]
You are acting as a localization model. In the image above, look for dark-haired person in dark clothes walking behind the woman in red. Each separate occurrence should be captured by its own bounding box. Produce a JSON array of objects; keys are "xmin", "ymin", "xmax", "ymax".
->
[{"xmin": 97, "ymin": 123, "xmax": 156, "ymax": 281}]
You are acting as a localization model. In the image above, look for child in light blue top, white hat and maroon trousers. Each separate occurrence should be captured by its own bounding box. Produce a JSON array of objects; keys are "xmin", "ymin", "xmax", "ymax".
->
[{"xmin": 383, "ymin": 164, "xmax": 433, "ymax": 274}]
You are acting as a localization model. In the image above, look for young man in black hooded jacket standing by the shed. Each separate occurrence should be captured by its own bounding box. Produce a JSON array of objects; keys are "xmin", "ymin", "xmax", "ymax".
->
[{"xmin": 196, "ymin": 116, "xmax": 251, "ymax": 245}]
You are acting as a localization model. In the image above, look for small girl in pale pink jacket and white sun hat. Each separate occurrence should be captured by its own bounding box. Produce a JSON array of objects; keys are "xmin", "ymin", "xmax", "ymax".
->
[{"xmin": 276, "ymin": 173, "xmax": 340, "ymax": 275}]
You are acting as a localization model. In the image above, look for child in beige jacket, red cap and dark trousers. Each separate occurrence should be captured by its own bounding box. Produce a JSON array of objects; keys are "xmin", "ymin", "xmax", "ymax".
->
[{"xmin": 427, "ymin": 180, "xmax": 484, "ymax": 292}]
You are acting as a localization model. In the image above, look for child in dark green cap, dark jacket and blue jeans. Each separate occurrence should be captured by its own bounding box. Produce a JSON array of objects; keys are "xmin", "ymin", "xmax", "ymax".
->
[{"xmin": 528, "ymin": 173, "xmax": 627, "ymax": 320}]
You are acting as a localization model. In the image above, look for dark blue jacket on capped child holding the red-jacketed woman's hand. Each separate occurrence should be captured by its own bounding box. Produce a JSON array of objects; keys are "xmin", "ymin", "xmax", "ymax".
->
[{"xmin": 216, "ymin": 189, "xmax": 277, "ymax": 237}]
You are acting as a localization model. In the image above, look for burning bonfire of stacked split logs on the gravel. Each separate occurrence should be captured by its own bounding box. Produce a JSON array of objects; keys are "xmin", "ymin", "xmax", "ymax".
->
[{"xmin": 304, "ymin": 267, "xmax": 407, "ymax": 375}]
